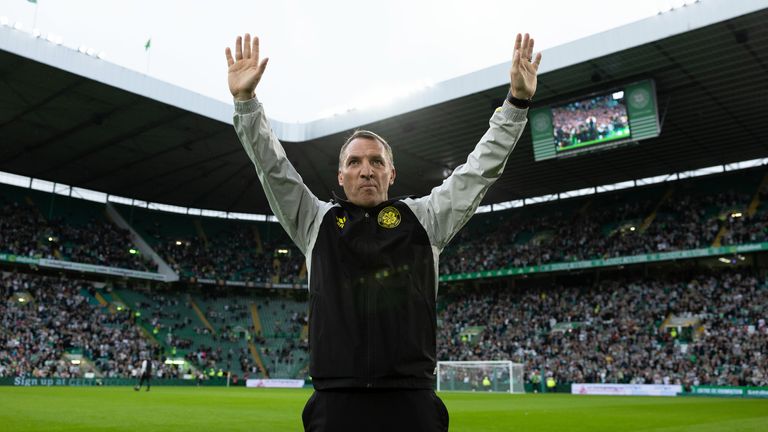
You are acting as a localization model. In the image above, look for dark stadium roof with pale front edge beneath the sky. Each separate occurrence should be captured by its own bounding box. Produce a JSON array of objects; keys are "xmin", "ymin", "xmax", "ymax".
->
[{"xmin": 0, "ymin": 0, "xmax": 768, "ymax": 213}]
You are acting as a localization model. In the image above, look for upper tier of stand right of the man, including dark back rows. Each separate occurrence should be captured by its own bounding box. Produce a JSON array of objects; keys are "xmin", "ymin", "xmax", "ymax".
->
[{"xmin": 441, "ymin": 170, "xmax": 767, "ymax": 274}]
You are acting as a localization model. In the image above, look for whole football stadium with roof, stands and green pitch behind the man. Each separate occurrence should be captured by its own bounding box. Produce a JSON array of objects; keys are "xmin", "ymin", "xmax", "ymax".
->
[{"xmin": 0, "ymin": 0, "xmax": 768, "ymax": 431}]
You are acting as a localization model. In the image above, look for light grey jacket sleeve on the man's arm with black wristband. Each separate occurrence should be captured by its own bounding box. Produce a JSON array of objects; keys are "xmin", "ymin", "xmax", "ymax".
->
[{"xmin": 404, "ymin": 101, "xmax": 528, "ymax": 250}]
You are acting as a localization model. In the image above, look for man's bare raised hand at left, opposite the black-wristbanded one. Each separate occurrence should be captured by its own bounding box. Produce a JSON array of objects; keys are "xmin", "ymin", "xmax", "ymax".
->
[{"xmin": 224, "ymin": 33, "xmax": 269, "ymax": 101}]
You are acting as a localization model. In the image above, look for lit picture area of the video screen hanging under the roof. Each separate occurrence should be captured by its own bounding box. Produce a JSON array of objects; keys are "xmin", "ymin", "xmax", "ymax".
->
[{"xmin": 552, "ymin": 91, "xmax": 631, "ymax": 153}]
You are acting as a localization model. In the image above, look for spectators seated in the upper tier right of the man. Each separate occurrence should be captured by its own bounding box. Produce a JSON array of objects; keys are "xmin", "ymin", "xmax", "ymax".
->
[{"xmin": 440, "ymin": 187, "xmax": 768, "ymax": 274}]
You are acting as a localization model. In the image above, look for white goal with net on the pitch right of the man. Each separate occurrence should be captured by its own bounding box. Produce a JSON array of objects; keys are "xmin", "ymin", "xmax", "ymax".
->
[{"xmin": 437, "ymin": 361, "xmax": 525, "ymax": 393}]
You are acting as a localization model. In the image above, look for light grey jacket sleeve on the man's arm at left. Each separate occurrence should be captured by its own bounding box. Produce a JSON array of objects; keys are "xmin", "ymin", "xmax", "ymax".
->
[{"xmin": 234, "ymin": 98, "xmax": 321, "ymax": 255}]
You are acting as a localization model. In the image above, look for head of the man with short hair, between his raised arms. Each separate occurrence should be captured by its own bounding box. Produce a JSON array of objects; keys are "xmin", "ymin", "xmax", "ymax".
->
[{"xmin": 339, "ymin": 138, "xmax": 395, "ymax": 207}]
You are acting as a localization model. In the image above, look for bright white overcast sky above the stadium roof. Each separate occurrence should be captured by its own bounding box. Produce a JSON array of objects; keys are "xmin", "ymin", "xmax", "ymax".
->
[{"xmin": 0, "ymin": 0, "xmax": 684, "ymax": 122}]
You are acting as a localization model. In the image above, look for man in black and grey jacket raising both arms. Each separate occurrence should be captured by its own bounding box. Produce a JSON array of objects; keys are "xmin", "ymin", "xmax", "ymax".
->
[{"xmin": 226, "ymin": 34, "xmax": 541, "ymax": 432}]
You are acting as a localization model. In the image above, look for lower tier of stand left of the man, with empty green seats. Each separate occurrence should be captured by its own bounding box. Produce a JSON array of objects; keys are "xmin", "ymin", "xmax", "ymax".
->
[{"xmin": 0, "ymin": 272, "xmax": 308, "ymax": 378}]
